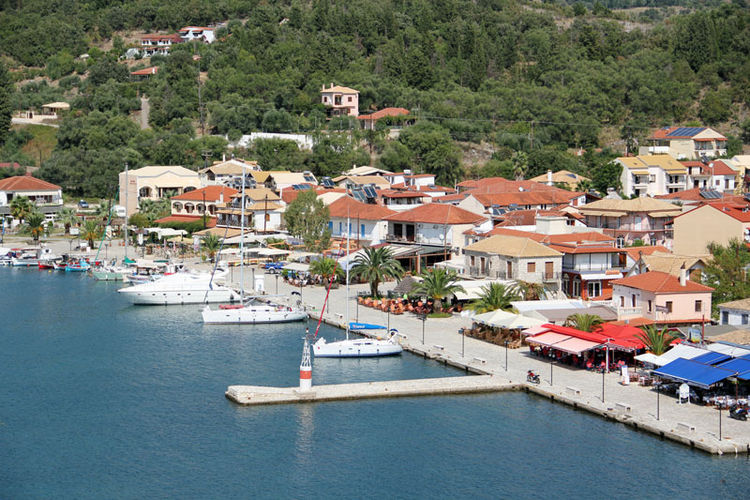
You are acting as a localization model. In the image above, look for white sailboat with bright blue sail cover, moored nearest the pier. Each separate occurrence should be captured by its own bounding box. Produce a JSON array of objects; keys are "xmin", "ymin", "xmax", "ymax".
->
[{"xmin": 313, "ymin": 205, "xmax": 404, "ymax": 358}]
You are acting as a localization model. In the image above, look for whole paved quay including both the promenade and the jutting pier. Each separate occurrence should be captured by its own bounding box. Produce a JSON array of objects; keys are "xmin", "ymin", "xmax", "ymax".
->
[{"xmin": 226, "ymin": 275, "xmax": 750, "ymax": 456}]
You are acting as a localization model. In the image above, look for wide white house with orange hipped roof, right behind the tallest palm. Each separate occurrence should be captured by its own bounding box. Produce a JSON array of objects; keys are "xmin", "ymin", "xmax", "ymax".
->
[{"xmin": 384, "ymin": 203, "xmax": 492, "ymax": 253}]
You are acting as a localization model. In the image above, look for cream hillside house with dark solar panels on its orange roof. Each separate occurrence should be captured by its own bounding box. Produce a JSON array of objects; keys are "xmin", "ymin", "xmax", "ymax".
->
[{"xmin": 639, "ymin": 127, "xmax": 727, "ymax": 160}]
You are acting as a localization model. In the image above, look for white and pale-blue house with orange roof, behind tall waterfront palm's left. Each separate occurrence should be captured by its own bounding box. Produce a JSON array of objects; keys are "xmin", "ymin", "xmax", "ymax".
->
[{"xmin": 328, "ymin": 195, "xmax": 396, "ymax": 245}]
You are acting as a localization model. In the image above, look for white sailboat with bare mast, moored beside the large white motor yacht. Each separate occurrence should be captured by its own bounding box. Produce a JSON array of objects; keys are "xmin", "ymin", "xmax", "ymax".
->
[{"xmin": 201, "ymin": 167, "xmax": 307, "ymax": 325}]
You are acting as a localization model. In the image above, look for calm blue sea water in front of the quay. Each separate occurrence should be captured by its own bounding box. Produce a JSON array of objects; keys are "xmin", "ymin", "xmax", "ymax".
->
[{"xmin": 0, "ymin": 268, "xmax": 750, "ymax": 498}]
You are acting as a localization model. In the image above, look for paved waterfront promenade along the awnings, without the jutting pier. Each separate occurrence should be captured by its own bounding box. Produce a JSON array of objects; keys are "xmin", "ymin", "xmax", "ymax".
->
[{"xmin": 233, "ymin": 269, "xmax": 750, "ymax": 453}]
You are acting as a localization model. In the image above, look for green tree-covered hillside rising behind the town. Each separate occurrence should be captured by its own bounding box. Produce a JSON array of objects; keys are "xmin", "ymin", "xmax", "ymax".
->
[{"xmin": 0, "ymin": 0, "xmax": 750, "ymax": 195}]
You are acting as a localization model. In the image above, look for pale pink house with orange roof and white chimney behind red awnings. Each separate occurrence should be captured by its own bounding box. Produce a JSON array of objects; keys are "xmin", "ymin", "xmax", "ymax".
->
[{"xmin": 612, "ymin": 269, "xmax": 713, "ymax": 325}]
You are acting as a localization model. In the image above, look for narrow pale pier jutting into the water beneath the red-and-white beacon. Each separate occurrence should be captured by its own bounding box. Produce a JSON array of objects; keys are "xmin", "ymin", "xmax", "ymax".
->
[{"xmin": 225, "ymin": 375, "xmax": 519, "ymax": 406}]
